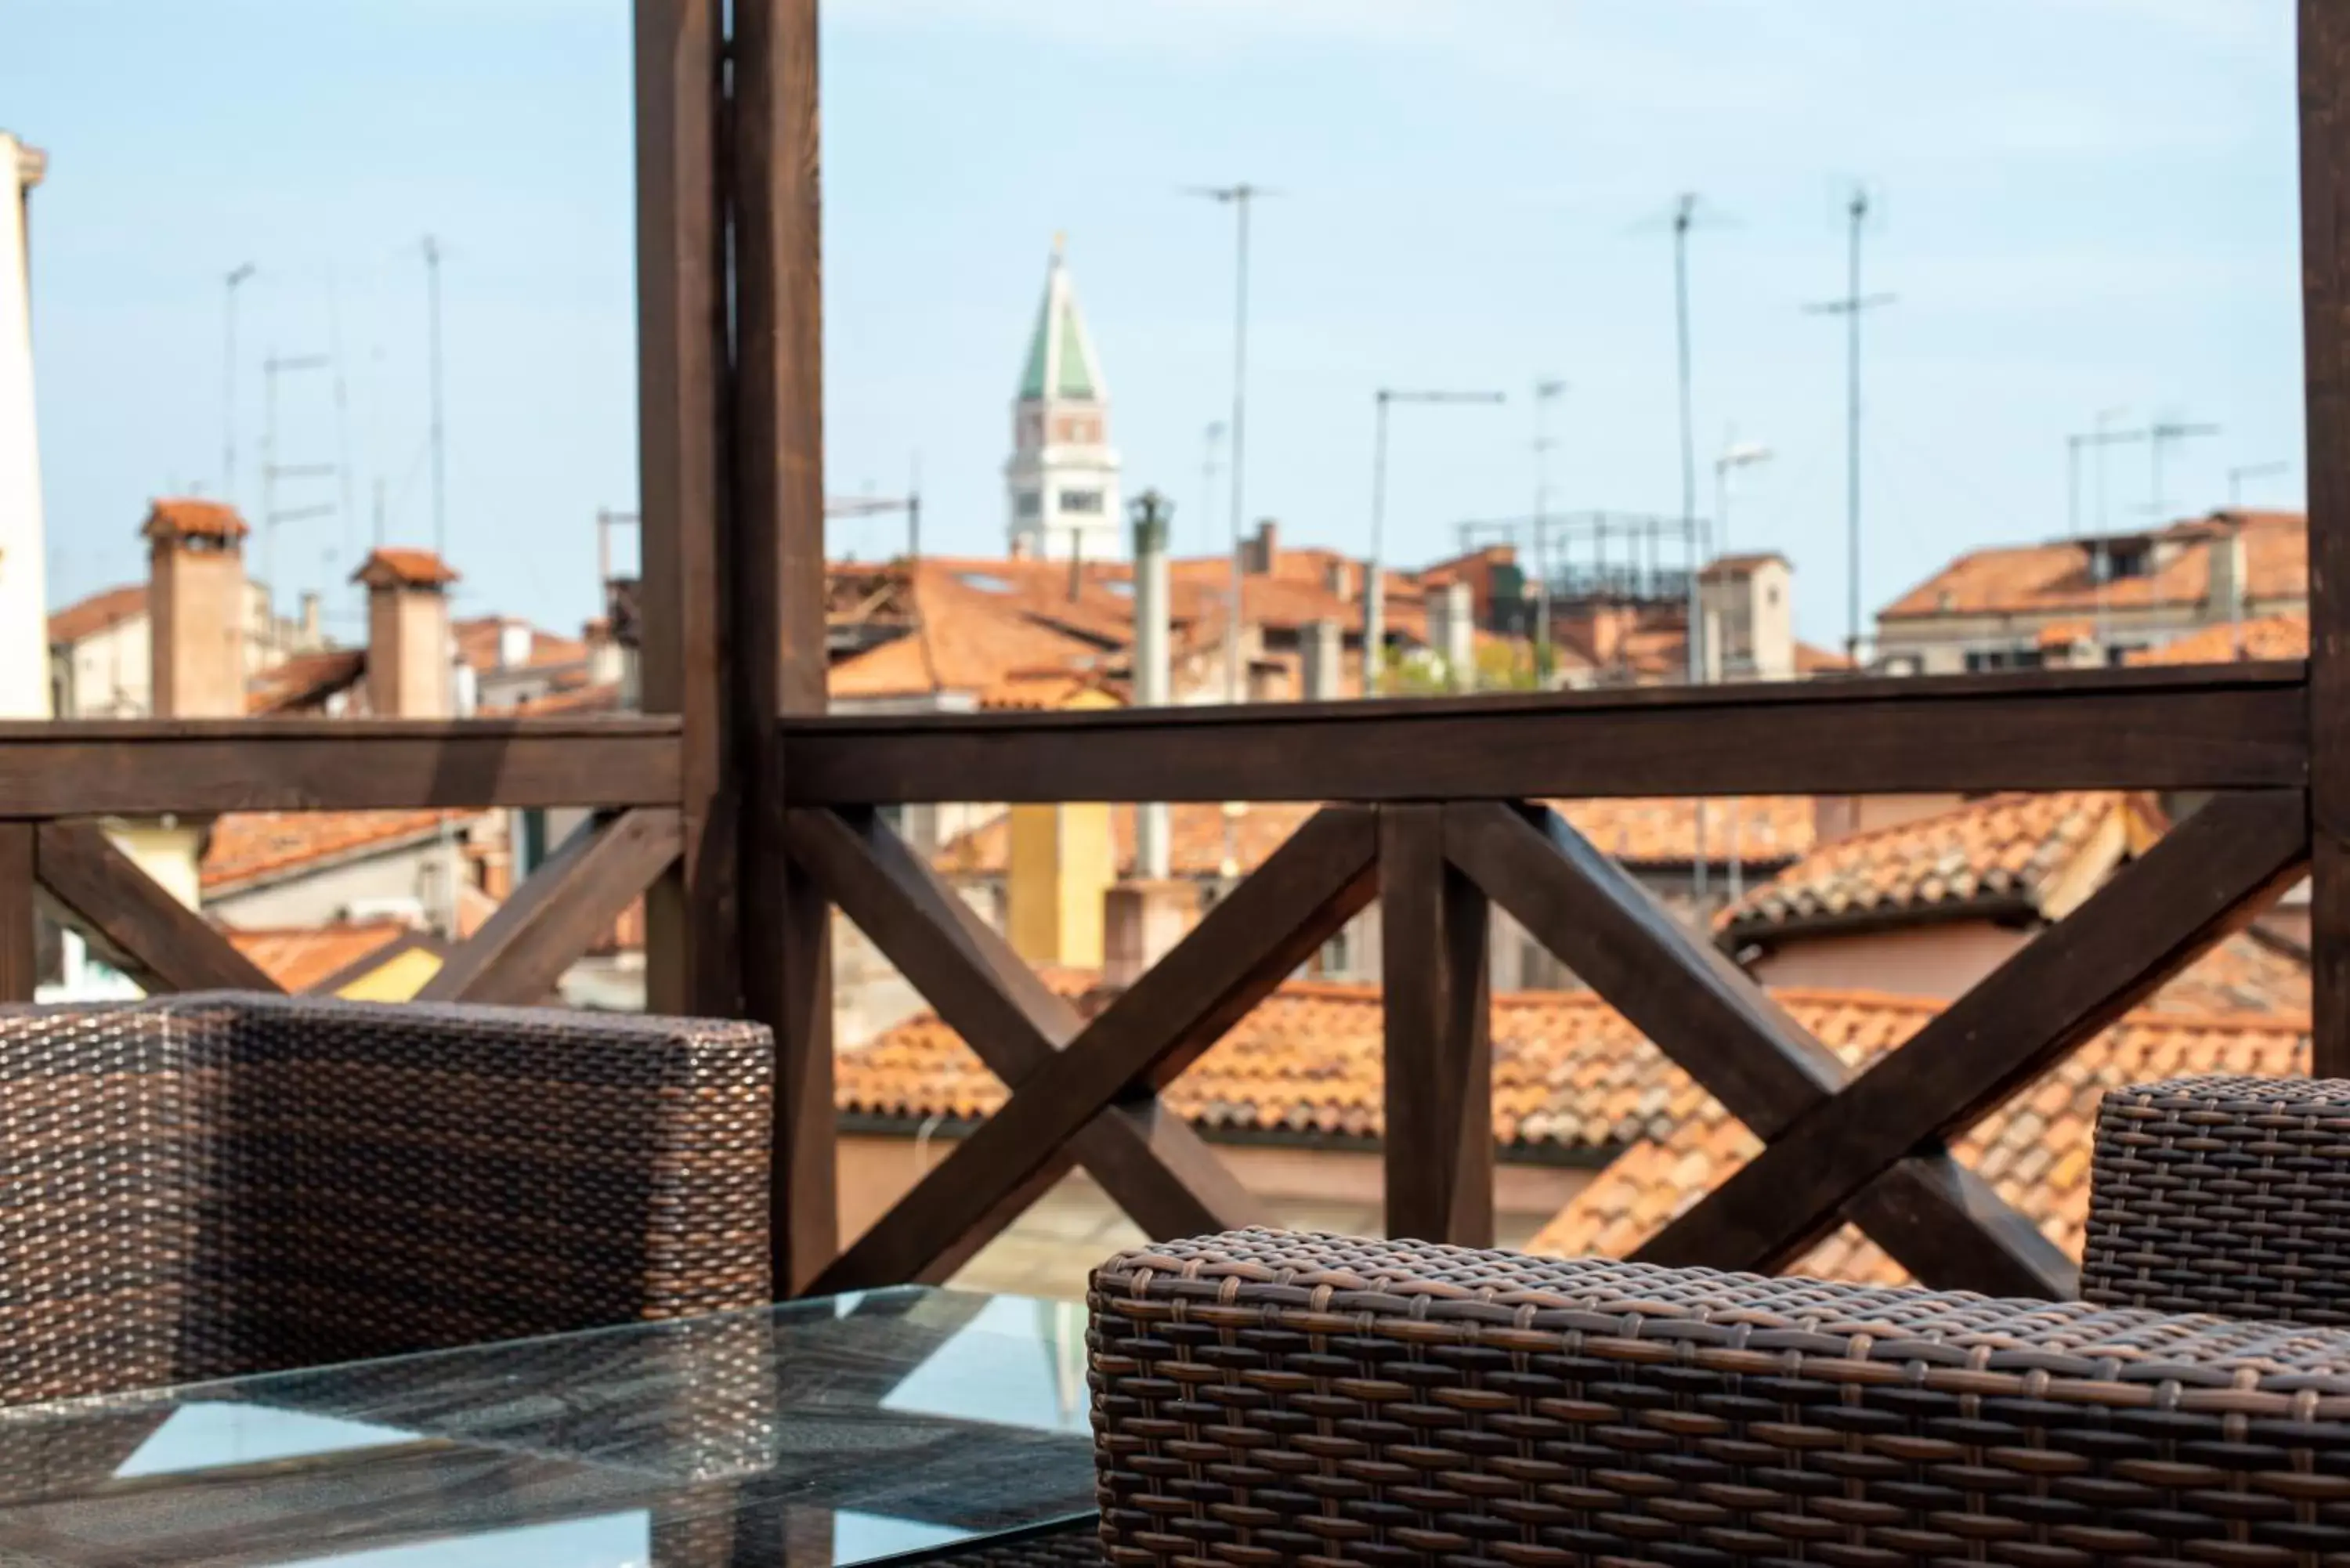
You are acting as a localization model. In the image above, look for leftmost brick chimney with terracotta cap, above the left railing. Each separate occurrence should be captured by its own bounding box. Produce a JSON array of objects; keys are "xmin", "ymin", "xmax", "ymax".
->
[{"xmin": 139, "ymin": 498, "xmax": 247, "ymax": 719}]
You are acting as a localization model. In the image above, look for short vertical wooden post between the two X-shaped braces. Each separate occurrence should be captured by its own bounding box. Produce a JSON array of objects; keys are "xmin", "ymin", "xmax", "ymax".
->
[{"xmin": 1379, "ymin": 807, "xmax": 1492, "ymax": 1246}]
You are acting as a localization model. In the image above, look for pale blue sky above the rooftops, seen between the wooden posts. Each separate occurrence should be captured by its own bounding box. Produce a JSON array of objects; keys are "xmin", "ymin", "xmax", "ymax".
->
[{"xmin": 0, "ymin": 0, "xmax": 2303, "ymax": 641}]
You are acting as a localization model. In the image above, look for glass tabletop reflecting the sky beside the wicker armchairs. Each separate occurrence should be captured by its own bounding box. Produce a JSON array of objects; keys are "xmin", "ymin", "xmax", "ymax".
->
[{"xmin": 0, "ymin": 1286, "xmax": 1095, "ymax": 1568}]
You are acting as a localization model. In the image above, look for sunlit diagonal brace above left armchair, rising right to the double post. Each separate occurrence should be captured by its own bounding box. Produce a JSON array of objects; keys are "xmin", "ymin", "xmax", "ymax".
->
[{"xmin": 416, "ymin": 807, "xmax": 682, "ymax": 1006}]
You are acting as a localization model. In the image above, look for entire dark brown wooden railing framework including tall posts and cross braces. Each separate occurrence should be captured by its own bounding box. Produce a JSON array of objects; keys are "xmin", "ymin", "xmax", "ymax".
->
[{"xmin": 0, "ymin": 0, "xmax": 2350, "ymax": 1295}]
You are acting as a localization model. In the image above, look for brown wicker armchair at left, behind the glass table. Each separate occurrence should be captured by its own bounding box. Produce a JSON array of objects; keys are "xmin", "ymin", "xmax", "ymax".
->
[{"xmin": 0, "ymin": 992, "xmax": 773, "ymax": 1404}]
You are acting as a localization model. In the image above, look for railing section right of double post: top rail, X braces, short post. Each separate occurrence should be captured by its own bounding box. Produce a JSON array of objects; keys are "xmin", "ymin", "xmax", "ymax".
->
[{"xmin": 783, "ymin": 665, "xmax": 2308, "ymax": 1295}]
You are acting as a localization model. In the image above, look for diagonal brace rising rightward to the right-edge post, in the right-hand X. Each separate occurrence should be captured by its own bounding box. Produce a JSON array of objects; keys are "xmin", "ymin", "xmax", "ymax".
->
[{"xmin": 1636, "ymin": 790, "xmax": 2308, "ymax": 1272}]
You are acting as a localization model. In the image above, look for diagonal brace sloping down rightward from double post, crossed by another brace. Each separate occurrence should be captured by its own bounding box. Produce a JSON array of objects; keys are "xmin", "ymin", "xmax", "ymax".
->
[{"xmin": 790, "ymin": 811, "xmax": 1267, "ymax": 1251}]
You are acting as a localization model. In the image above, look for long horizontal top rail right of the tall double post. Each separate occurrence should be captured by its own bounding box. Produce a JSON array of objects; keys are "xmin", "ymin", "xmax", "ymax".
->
[{"xmin": 785, "ymin": 665, "xmax": 2310, "ymax": 807}]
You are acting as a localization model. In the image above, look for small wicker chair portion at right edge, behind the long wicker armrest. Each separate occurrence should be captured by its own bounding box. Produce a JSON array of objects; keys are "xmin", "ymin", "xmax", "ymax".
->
[{"xmin": 2082, "ymin": 1077, "xmax": 2350, "ymax": 1324}]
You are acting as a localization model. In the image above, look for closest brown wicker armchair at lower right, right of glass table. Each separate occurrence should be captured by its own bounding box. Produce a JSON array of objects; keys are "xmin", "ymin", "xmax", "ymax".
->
[{"xmin": 1090, "ymin": 1079, "xmax": 2350, "ymax": 1568}]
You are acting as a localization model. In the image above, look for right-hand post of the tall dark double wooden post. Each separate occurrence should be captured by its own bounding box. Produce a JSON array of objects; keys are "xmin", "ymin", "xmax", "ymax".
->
[{"xmin": 728, "ymin": 0, "xmax": 839, "ymax": 1293}]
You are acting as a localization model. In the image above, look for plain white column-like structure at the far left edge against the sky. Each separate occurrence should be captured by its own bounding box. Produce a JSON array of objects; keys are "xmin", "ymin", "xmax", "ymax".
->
[{"xmin": 0, "ymin": 132, "xmax": 49, "ymax": 719}]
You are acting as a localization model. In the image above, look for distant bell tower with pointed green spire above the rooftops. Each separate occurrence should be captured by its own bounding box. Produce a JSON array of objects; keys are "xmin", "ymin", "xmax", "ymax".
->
[{"xmin": 1003, "ymin": 235, "xmax": 1119, "ymax": 559}]
